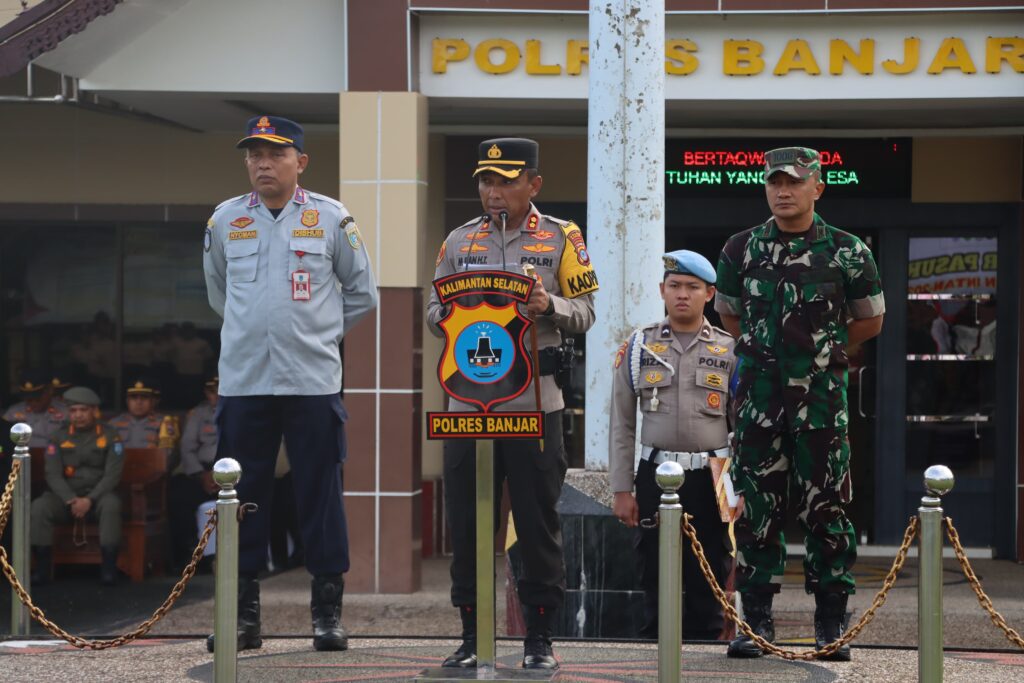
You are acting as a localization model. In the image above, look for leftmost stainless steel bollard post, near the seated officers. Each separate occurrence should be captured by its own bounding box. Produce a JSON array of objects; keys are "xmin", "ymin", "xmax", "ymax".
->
[{"xmin": 9, "ymin": 422, "xmax": 32, "ymax": 636}]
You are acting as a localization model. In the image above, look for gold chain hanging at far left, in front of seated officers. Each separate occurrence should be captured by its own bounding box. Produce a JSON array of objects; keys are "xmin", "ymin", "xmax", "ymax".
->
[{"xmin": 0, "ymin": 460, "xmax": 217, "ymax": 650}]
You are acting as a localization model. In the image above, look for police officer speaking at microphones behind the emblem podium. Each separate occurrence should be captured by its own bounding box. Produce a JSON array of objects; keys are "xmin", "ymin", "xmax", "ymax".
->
[{"xmin": 427, "ymin": 138, "xmax": 597, "ymax": 669}]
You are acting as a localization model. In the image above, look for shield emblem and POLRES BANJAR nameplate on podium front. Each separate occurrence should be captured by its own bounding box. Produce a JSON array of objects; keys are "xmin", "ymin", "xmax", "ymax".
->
[{"xmin": 427, "ymin": 270, "xmax": 544, "ymax": 439}]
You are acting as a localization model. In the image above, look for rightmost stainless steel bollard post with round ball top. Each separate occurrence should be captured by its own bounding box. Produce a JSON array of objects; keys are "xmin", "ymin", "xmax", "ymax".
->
[{"xmin": 918, "ymin": 465, "xmax": 953, "ymax": 683}]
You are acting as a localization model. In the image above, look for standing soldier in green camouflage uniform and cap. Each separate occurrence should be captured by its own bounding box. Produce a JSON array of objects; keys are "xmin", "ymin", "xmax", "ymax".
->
[{"xmin": 715, "ymin": 147, "xmax": 885, "ymax": 659}]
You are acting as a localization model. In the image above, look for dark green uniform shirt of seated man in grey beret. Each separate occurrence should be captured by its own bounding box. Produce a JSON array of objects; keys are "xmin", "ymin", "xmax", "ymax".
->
[{"xmin": 45, "ymin": 424, "xmax": 124, "ymax": 503}]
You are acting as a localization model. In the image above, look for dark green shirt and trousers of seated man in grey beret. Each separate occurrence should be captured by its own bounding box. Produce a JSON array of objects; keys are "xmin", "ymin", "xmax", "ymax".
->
[{"xmin": 32, "ymin": 424, "xmax": 124, "ymax": 548}]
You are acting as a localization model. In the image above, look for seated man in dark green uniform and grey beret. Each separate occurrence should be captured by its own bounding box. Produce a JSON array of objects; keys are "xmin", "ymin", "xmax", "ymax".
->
[{"xmin": 32, "ymin": 387, "xmax": 124, "ymax": 586}]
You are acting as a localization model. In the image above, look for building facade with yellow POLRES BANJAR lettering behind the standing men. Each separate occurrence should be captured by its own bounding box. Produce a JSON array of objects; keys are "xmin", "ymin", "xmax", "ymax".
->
[{"xmin": 0, "ymin": 0, "xmax": 1024, "ymax": 592}]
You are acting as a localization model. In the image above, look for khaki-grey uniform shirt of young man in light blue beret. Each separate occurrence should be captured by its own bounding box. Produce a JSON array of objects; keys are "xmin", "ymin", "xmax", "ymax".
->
[{"xmin": 608, "ymin": 318, "xmax": 736, "ymax": 494}]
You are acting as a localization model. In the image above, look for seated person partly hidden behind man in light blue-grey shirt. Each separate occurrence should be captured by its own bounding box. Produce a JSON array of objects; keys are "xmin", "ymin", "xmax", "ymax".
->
[{"xmin": 167, "ymin": 377, "xmax": 220, "ymax": 566}]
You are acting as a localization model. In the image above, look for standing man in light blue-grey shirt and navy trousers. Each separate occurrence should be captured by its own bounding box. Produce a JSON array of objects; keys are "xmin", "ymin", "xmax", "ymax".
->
[{"xmin": 203, "ymin": 116, "xmax": 377, "ymax": 650}]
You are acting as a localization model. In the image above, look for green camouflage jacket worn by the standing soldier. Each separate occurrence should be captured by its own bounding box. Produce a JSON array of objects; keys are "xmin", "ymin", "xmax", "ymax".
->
[{"xmin": 715, "ymin": 214, "xmax": 885, "ymax": 431}]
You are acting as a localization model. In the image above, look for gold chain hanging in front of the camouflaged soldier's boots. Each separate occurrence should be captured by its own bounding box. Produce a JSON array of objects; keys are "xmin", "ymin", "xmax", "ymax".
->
[{"xmin": 682, "ymin": 513, "xmax": 918, "ymax": 661}]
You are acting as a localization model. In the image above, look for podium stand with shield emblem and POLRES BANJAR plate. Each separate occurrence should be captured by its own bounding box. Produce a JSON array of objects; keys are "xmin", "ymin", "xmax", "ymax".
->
[{"xmin": 414, "ymin": 270, "xmax": 556, "ymax": 681}]
